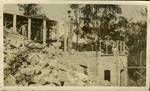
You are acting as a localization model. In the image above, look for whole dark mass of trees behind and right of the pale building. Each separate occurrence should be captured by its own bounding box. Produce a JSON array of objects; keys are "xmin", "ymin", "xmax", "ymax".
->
[{"xmin": 69, "ymin": 4, "xmax": 147, "ymax": 86}]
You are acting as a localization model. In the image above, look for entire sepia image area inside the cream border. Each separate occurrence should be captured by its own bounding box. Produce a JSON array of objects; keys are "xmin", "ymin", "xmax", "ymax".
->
[{"xmin": 3, "ymin": 4, "xmax": 147, "ymax": 87}]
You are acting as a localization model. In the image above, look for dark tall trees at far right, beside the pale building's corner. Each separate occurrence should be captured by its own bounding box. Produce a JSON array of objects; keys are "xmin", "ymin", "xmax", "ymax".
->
[{"xmin": 126, "ymin": 9, "xmax": 147, "ymax": 86}]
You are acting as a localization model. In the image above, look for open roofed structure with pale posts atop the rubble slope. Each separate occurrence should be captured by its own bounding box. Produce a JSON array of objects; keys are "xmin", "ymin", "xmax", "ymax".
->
[{"xmin": 3, "ymin": 12, "xmax": 57, "ymax": 44}]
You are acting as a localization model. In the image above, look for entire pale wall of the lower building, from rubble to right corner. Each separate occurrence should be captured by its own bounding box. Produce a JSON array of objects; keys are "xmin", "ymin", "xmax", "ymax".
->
[{"xmin": 63, "ymin": 53, "xmax": 127, "ymax": 86}]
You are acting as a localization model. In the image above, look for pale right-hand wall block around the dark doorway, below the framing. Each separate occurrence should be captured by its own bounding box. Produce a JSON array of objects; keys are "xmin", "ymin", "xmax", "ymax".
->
[{"xmin": 97, "ymin": 56, "xmax": 127, "ymax": 86}]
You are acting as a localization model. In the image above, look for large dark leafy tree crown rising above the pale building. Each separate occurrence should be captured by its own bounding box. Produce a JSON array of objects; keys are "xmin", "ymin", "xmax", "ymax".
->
[{"xmin": 82, "ymin": 4, "xmax": 121, "ymax": 39}]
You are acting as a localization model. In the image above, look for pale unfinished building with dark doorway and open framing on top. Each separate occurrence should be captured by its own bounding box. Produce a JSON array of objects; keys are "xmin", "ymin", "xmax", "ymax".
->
[{"xmin": 65, "ymin": 40, "xmax": 128, "ymax": 86}]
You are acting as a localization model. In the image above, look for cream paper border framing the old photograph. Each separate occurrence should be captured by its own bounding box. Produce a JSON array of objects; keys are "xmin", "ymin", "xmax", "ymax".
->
[{"xmin": 0, "ymin": 0, "xmax": 150, "ymax": 91}]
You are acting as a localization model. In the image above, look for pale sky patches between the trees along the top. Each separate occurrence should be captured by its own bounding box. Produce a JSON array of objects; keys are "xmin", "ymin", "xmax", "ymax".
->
[{"xmin": 4, "ymin": 4, "xmax": 145, "ymax": 21}]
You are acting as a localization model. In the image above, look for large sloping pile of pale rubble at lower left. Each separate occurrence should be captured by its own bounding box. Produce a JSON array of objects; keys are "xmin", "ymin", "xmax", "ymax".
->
[{"xmin": 4, "ymin": 31, "xmax": 94, "ymax": 86}]
